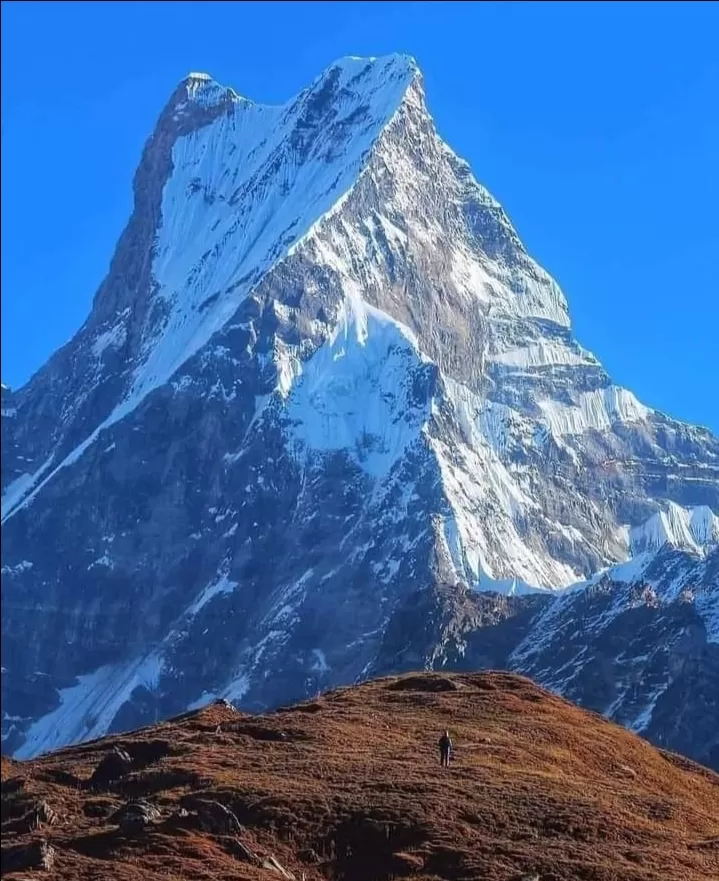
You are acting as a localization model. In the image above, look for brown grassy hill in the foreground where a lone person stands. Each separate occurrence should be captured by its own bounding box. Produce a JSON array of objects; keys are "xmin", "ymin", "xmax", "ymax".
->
[{"xmin": 2, "ymin": 673, "xmax": 719, "ymax": 881}]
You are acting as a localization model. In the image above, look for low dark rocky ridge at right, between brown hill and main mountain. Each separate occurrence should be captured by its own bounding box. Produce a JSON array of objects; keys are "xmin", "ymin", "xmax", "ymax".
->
[{"xmin": 371, "ymin": 545, "xmax": 719, "ymax": 769}]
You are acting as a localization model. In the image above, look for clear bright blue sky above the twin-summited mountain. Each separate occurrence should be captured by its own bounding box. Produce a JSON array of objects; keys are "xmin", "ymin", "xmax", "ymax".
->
[{"xmin": 2, "ymin": 0, "xmax": 719, "ymax": 432}]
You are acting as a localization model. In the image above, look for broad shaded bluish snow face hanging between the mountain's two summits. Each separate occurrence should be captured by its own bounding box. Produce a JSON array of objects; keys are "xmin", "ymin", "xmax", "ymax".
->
[{"xmin": 132, "ymin": 56, "xmax": 428, "ymax": 404}]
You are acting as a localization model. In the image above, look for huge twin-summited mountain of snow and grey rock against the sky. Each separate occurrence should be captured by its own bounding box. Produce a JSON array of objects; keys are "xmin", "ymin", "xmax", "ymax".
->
[{"xmin": 2, "ymin": 56, "xmax": 719, "ymax": 755}]
